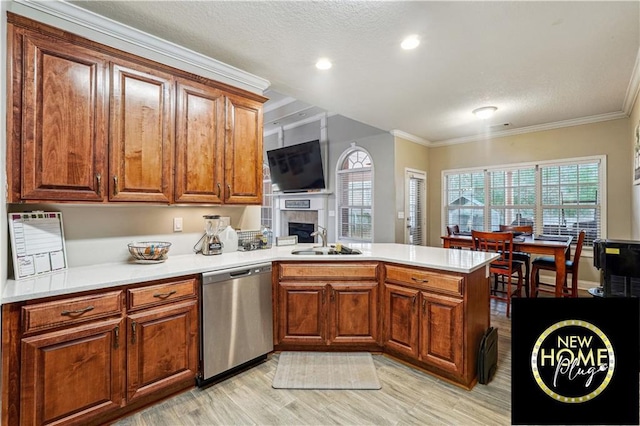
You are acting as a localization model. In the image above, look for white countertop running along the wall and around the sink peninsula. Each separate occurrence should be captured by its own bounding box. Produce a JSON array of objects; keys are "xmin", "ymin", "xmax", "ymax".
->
[{"xmin": 2, "ymin": 243, "xmax": 497, "ymax": 304}]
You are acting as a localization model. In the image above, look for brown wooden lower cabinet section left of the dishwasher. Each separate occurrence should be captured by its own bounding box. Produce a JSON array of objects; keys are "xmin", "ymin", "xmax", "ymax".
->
[{"xmin": 2, "ymin": 276, "xmax": 199, "ymax": 425}]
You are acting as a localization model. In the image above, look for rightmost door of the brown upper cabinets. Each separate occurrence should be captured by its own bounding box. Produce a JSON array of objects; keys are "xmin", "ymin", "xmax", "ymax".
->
[{"xmin": 224, "ymin": 96, "xmax": 262, "ymax": 204}]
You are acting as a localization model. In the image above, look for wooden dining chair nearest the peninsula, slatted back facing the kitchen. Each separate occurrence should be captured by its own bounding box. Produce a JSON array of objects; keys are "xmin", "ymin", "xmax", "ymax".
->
[{"xmin": 471, "ymin": 230, "xmax": 523, "ymax": 317}]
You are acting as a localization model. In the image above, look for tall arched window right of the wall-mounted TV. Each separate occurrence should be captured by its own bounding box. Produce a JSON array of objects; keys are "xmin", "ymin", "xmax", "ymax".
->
[{"xmin": 336, "ymin": 144, "xmax": 373, "ymax": 242}]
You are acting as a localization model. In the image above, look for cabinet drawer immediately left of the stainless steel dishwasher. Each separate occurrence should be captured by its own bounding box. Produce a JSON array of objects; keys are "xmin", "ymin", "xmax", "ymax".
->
[{"xmin": 128, "ymin": 278, "xmax": 197, "ymax": 309}]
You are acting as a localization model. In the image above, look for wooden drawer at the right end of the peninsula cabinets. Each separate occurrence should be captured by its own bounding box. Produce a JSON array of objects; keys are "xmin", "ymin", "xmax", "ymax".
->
[{"xmin": 385, "ymin": 265, "xmax": 464, "ymax": 296}]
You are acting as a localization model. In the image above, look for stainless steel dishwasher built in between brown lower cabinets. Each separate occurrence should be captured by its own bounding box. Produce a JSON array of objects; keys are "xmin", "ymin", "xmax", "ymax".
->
[{"xmin": 197, "ymin": 263, "xmax": 273, "ymax": 386}]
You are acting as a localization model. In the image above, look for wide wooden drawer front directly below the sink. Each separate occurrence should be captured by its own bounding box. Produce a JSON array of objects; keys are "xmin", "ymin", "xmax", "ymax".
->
[{"xmin": 279, "ymin": 262, "xmax": 378, "ymax": 280}]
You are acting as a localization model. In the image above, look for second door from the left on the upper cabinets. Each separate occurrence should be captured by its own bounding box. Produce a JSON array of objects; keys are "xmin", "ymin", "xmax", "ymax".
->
[{"xmin": 109, "ymin": 63, "xmax": 174, "ymax": 203}]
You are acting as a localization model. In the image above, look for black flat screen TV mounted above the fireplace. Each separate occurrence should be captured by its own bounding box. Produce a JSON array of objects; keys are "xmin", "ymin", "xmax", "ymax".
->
[{"xmin": 267, "ymin": 140, "xmax": 325, "ymax": 192}]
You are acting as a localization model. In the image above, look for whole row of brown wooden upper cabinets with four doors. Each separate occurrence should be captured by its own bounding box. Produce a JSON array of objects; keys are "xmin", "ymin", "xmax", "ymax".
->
[{"xmin": 7, "ymin": 17, "xmax": 266, "ymax": 204}]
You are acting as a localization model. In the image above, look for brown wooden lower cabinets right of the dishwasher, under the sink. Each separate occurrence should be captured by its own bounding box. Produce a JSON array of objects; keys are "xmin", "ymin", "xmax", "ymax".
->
[{"xmin": 274, "ymin": 261, "xmax": 490, "ymax": 389}]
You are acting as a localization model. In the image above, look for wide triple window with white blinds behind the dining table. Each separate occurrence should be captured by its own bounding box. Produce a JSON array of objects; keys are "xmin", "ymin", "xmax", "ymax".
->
[{"xmin": 443, "ymin": 156, "xmax": 606, "ymax": 246}]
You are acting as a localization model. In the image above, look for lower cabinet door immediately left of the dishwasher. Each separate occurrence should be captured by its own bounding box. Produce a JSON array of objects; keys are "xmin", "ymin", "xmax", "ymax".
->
[{"xmin": 127, "ymin": 300, "xmax": 198, "ymax": 402}]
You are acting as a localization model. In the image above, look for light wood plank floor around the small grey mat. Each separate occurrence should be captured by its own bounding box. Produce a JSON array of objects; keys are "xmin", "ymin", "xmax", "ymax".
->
[{"xmin": 115, "ymin": 301, "xmax": 511, "ymax": 426}]
